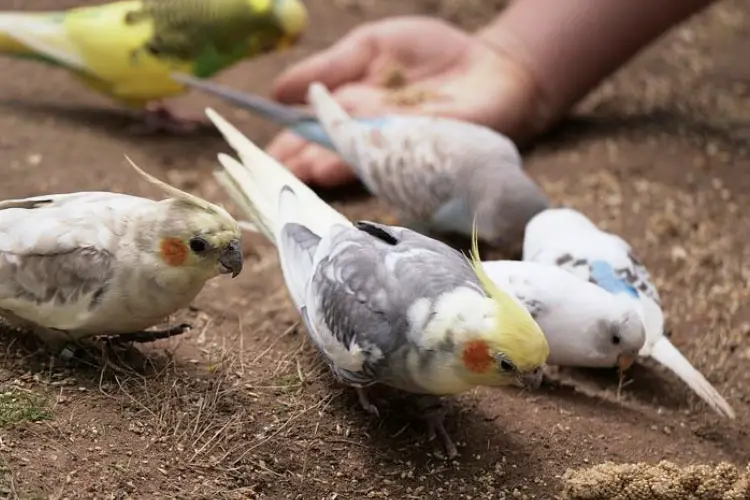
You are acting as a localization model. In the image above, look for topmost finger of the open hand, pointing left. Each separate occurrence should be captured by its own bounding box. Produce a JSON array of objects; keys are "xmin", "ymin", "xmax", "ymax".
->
[{"xmin": 273, "ymin": 26, "xmax": 375, "ymax": 104}]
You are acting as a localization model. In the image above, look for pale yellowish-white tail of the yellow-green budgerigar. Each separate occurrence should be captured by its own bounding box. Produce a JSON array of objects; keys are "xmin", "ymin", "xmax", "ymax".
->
[{"xmin": 0, "ymin": 12, "xmax": 86, "ymax": 69}]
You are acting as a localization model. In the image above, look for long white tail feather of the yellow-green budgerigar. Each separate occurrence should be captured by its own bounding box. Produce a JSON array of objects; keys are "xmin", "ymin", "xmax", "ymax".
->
[{"xmin": 0, "ymin": 12, "xmax": 87, "ymax": 70}]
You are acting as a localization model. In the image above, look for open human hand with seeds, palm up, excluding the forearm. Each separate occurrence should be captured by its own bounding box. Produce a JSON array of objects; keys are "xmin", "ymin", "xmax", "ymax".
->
[{"xmin": 267, "ymin": 17, "xmax": 535, "ymax": 187}]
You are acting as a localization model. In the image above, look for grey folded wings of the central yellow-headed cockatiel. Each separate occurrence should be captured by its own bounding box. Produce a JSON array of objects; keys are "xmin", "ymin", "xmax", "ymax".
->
[{"xmin": 308, "ymin": 221, "xmax": 480, "ymax": 385}]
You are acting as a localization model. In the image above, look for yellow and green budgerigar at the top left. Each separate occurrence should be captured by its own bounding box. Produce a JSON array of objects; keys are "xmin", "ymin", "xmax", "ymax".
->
[{"xmin": 0, "ymin": 0, "xmax": 307, "ymax": 133}]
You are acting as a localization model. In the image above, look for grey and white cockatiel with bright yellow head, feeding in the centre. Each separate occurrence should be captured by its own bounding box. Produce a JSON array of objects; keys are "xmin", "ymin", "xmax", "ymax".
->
[{"xmin": 207, "ymin": 105, "xmax": 549, "ymax": 457}]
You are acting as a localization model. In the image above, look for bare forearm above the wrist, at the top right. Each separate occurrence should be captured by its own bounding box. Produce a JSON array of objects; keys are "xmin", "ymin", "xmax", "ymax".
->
[{"xmin": 476, "ymin": 0, "xmax": 713, "ymax": 131}]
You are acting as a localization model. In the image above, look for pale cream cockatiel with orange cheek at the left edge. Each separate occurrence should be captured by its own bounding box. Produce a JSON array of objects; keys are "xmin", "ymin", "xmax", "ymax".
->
[{"xmin": 0, "ymin": 158, "xmax": 243, "ymax": 352}]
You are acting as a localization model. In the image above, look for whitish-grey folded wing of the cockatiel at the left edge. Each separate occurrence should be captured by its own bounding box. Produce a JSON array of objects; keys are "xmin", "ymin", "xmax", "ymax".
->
[{"xmin": 0, "ymin": 192, "xmax": 153, "ymax": 330}]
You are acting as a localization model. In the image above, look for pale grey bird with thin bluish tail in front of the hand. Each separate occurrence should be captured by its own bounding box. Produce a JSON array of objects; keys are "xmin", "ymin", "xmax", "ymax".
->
[{"xmin": 174, "ymin": 75, "xmax": 549, "ymax": 255}]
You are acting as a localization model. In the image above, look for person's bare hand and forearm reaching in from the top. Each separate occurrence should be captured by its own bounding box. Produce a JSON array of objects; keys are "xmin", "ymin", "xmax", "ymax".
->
[{"xmin": 267, "ymin": 0, "xmax": 713, "ymax": 187}]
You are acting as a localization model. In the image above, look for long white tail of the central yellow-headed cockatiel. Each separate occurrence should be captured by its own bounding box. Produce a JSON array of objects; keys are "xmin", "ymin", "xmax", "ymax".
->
[{"xmin": 206, "ymin": 108, "xmax": 351, "ymax": 246}]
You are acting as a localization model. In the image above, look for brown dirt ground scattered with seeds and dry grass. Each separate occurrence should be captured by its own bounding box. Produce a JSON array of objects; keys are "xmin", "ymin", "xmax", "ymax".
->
[{"xmin": 0, "ymin": 0, "xmax": 750, "ymax": 499}]
